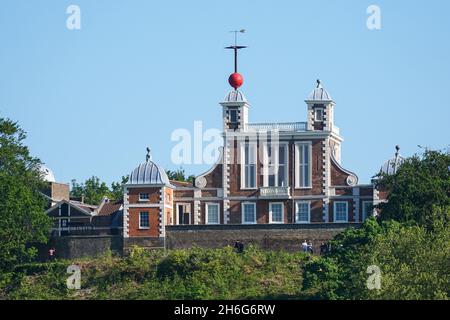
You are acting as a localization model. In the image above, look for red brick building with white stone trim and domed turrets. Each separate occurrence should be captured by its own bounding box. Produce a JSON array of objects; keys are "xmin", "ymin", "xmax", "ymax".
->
[{"xmin": 123, "ymin": 80, "xmax": 379, "ymax": 238}]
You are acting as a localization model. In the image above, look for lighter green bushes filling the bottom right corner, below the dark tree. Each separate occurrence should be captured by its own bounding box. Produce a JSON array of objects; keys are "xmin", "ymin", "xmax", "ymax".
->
[{"xmin": 303, "ymin": 219, "xmax": 450, "ymax": 300}]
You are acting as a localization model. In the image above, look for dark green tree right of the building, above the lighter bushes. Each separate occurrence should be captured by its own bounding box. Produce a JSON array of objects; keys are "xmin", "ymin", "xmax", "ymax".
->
[{"xmin": 376, "ymin": 150, "xmax": 450, "ymax": 226}]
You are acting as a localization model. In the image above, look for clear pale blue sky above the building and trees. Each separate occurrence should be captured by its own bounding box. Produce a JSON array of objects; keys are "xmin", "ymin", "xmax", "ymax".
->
[{"xmin": 0, "ymin": 0, "xmax": 450, "ymax": 183}]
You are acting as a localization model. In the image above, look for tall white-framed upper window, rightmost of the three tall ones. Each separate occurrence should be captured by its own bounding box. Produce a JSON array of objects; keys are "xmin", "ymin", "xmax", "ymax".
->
[{"xmin": 295, "ymin": 141, "xmax": 312, "ymax": 189}]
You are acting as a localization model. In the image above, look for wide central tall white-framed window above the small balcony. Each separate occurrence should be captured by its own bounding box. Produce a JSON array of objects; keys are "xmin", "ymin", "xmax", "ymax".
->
[{"xmin": 263, "ymin": 143, "xmax": 289, "ymax": 187}]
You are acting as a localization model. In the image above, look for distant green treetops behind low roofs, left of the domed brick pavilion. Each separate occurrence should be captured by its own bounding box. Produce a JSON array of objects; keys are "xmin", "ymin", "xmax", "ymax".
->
[{"xmin": 70, "ymin": 176, "xmax": 128, "ymax": 205}]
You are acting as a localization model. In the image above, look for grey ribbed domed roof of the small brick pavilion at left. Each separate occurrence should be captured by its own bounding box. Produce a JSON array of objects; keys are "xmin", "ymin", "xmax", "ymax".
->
[{"xmin": 128, "ymin": 160, "xmax": 170, "ymax": 185}]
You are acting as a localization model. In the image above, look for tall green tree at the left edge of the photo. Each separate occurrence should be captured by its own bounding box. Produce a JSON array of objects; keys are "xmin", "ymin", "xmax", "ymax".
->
[{"xmin": 0, "ymin": 118, "xmax": 51, "ymax": 270}]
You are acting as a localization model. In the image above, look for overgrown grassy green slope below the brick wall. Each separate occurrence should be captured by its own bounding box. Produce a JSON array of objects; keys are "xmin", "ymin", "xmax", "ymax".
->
[{"xmin": 0, "ymin": 247, "xmax": 314, "ymax": 299}]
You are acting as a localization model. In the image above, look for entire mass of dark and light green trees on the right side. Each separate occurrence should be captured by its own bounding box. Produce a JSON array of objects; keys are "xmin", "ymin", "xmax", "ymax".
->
[{"xmin": 303, "ymin": 150, "xmax": 450, "ymax": 299}]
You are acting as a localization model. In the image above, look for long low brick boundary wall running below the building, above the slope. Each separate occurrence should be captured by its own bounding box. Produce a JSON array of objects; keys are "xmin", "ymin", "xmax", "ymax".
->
[{"xmin": 38, "ymin": 223, "xmax": 361, "ymax": 260}]
